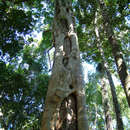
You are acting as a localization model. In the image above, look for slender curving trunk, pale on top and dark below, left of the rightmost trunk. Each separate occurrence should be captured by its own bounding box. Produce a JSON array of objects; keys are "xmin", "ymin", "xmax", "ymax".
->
[{"xmin": 95, "ymin": 14, "xmax": 124, "ymax": 130}]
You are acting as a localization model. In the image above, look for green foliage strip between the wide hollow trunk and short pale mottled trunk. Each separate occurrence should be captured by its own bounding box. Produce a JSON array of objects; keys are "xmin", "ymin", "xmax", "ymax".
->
[{"xmin": 86, "ymin": 73, "xmax": 105, "ymax": 130}]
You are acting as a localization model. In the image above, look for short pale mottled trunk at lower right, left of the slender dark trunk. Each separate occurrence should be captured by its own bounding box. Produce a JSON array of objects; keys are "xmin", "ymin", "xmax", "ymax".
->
[{"xmin": 101, "ymin": 78, "xmax": 113, "ymax": 130}]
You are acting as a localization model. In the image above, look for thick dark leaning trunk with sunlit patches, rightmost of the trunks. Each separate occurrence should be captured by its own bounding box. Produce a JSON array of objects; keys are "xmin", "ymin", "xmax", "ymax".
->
[{"xmin": 99, "ymin": 0, "xmax": 130, "ymax": 107}]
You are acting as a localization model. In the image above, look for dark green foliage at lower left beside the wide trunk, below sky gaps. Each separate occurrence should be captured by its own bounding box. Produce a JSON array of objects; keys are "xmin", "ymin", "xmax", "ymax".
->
[{"xmin": 0, "ymin": 59, "xmax": 49, "ymax": 130}]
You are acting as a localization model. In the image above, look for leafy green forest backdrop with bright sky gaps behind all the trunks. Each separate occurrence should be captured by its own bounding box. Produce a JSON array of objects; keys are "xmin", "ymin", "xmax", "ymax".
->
[{"xmin": 0, "ymin": 0, "xmax": 130, "ymax": 130}]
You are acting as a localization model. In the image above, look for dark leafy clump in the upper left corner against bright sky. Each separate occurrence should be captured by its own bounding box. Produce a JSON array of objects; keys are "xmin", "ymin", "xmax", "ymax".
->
[{"xmin": 0, "ymin": 1, "xmax": 34, "ymax": 57}]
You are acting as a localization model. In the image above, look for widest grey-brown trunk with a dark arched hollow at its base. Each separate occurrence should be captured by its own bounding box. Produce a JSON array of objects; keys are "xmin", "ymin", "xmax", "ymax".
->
[{"xmin": 41, "ymin": 0, "xmax": 88, "ymax": 130}]
